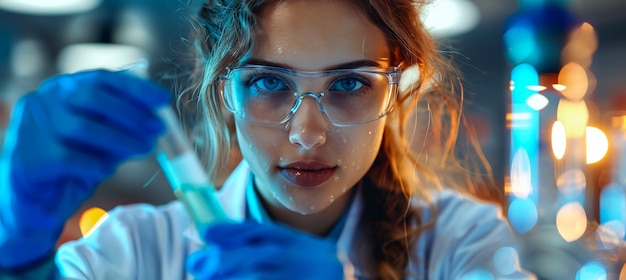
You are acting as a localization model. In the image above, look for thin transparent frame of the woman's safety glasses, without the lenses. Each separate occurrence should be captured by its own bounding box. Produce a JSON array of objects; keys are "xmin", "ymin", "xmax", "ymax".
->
[{"xmin": 220, "ymin": 64, "xmax": 402, "ymax": 127}]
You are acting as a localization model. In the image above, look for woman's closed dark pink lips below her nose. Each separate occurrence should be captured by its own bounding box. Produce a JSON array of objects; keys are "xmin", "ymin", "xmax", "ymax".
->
[{"xmin": 280, "ymin": 161, "xmax": 336, "ymax": 187}]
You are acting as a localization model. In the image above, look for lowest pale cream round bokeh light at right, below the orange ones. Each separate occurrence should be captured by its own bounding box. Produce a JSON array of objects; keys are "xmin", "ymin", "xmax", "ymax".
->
[{"xmin": 556, "ymin": 202, "xmax": 587, "ymax": 242}]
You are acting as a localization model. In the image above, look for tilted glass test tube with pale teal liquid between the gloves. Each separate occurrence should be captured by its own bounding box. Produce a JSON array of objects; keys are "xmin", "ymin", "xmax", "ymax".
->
[{"xmin": 121, "ymin": 60, "xmax": 228, "ymax": 234}]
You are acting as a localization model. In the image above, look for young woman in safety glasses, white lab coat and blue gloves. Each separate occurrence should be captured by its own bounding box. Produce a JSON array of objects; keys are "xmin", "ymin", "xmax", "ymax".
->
[{"xmin": 0, "ymin": 0, "xmax": 525, "ymax": 279}]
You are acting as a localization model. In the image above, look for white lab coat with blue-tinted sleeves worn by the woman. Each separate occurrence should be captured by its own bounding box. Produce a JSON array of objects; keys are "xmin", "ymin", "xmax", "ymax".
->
[{"xmin": 55, "ymin": 162, "xmax": 526, "ymax": 280}]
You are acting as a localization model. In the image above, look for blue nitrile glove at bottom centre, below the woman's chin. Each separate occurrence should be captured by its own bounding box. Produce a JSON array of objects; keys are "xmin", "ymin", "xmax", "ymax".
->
[{"xmin": 187, "ymin": 221, "xmax": 344, "ymax": 279}]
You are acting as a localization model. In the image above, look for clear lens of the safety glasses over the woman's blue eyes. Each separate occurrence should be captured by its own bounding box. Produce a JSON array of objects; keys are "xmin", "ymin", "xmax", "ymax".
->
[{"xmin": 224, "ymin": 66, "xmax": 400, "ymax": 125}]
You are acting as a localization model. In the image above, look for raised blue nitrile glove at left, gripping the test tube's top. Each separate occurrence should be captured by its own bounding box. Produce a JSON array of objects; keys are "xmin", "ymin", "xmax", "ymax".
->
[{"xmin": 0, "ymin": 70, "xmax": 171, "ymax": 270}]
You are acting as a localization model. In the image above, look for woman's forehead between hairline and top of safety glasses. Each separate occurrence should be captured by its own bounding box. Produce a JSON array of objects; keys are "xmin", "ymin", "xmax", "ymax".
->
[{"xmin": 250, "ymin": 0, "xmax": 390, "ymax": 70}]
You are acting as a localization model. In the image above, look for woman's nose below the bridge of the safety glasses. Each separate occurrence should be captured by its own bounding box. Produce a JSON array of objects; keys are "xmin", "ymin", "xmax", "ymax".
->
[{"xmin": 289, "ymin": 96, "xmax": 329, "ymax": 150}]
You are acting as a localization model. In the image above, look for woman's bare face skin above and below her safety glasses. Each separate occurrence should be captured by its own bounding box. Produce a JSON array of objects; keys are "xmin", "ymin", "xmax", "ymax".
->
[{"xmin": 236, "ymin": 0, "xmax": 390, "ymax": 214}]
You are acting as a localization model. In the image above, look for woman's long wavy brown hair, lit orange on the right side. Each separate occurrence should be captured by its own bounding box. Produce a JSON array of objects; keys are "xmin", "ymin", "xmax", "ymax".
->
[{"xmin": 179, "ymin": 0, "xmax": 502, "ymax": 279}]
